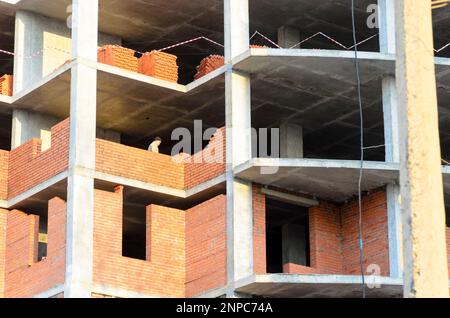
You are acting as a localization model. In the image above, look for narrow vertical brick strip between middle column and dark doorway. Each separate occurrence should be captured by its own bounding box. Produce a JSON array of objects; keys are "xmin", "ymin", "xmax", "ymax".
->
[{"xmin": 253, "ymin": 185, "xmax": 267, "ymax": 274}]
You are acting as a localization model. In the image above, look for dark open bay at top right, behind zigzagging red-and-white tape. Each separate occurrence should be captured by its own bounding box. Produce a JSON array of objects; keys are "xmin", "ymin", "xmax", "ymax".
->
[{"xmin": 250, "ymin": 0, "xmax": 379, "ymax": 52}]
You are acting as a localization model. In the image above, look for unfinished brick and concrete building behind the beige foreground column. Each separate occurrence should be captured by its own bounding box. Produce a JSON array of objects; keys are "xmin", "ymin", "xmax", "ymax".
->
[{"xmin": 0, "ymin": 0, "xmax": 450, "ymax": 298}]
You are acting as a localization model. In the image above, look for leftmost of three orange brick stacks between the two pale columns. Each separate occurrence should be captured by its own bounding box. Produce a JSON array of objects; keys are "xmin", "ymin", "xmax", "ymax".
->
[{"xmin": 97, "ymin": 45, "xmax": 139, "ymax": 72}]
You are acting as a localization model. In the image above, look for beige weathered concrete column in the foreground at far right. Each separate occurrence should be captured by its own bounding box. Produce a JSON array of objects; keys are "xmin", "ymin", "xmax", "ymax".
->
[{"xmin": 395, "ymin": 0, "xmax": 449, "ymax": 298}]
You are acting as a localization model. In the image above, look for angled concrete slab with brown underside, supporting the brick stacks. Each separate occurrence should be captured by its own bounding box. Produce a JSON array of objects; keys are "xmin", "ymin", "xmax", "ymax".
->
[{"xmin": 11, "ymin": 60, "xmax": 226, "ymax": 139}]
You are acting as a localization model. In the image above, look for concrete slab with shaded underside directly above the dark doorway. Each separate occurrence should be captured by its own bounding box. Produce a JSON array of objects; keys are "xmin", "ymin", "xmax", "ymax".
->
[{"xmin": 235, "ymin": 158, "xmax": 399, "ymax": 202}]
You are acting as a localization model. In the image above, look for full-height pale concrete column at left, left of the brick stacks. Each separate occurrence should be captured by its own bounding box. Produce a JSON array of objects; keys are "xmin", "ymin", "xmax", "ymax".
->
[{"xmin": 65, "ymin": 0, "xmax": 98, "ymax": 298}]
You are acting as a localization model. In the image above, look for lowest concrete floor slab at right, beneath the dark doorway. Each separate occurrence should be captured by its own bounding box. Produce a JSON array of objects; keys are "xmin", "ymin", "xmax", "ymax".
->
[{"xmin": 236, "ymin": 274, "xmax": 403, "ymax": 298}]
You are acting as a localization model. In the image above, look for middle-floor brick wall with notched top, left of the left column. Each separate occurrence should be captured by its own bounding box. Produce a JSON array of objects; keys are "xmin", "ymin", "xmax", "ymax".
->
[{"xmin": 8, "ymin": 119, "xmax": 70, "ymax": 198}]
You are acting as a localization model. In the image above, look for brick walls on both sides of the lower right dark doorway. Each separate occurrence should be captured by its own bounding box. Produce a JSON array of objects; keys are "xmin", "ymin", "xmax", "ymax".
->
[{"xmin": 253, "ymin": 187, "xmax": 389, "ymax": 276}]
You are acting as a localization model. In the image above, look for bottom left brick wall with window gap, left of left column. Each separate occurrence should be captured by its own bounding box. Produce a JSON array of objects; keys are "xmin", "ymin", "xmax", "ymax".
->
[{"xmin": 0, "ymin": 198, "xmax": 66, "ymax": 298}]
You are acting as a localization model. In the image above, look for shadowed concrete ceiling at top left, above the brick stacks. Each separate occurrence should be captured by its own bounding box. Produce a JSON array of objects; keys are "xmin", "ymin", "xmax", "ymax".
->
[{"xmin": 0, "ymin": 0, "xmax": 223, "ymax": 46}]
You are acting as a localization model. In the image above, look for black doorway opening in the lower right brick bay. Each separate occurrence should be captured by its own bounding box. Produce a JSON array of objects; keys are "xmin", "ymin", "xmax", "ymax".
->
[{"xmin": 266, "ymin": 198, "xmax": 310, "ymax": 274}]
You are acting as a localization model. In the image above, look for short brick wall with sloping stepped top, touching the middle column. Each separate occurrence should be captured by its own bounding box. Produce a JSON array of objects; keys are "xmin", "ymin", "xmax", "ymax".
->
[{"xmin": 184, "ymin": 128, "xmax": 226, "ymax": 189}]
